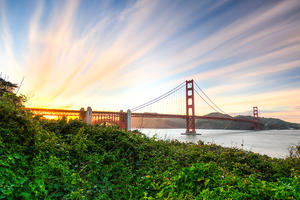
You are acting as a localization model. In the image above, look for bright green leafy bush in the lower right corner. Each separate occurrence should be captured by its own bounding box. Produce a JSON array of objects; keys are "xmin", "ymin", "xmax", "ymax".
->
[{"xmin": 163, "ymin": 163, "xmax": 300, "ymax": 199}]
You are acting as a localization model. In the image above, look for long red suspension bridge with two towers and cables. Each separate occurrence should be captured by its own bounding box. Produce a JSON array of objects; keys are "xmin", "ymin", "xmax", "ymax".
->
[{"xmin": 27, "ymin": 80, "xmax": 262, "ymax": 134}]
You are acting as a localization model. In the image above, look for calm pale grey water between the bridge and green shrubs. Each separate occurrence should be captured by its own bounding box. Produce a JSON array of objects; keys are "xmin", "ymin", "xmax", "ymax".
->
[{"xmin": 139, "ymin": 129, "xmax": 300, "ymax": 158}]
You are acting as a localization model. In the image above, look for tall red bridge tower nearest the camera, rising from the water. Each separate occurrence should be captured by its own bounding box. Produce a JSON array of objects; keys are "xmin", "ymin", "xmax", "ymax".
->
[{"xmin": 185, "ymin": 79, "xmax": 196, "ymax": 134}]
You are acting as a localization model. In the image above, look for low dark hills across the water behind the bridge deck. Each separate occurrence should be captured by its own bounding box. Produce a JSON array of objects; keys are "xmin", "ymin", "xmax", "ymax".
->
[{"xmin": 132, "ymin": 112, "xmax": 300, "ymax": 130}]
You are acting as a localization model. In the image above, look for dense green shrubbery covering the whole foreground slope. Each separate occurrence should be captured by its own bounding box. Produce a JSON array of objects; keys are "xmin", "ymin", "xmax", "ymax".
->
[{"xmin": 0, "ymin": 79, "xmax": 300, "ymax": 199}]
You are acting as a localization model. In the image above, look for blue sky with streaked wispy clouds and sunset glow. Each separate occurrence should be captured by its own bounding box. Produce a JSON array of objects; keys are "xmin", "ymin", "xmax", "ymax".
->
[{"xmin": 0, "ymin": 0, "xmax": 300, "ymax": 123}]
